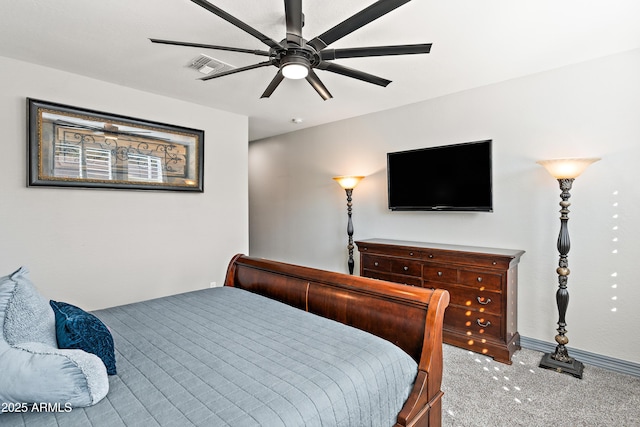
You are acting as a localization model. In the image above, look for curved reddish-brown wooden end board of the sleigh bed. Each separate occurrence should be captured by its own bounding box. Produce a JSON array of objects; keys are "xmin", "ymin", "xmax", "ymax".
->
[{"xmin": 224, "ymin": 254, "xmax": 449, "ymax": 427}]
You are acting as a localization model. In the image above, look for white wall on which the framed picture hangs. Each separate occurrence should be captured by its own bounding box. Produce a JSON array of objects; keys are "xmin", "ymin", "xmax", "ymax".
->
[{"xmin": 0, "ymin": 58, "xmax": 248, "ymax": 310}]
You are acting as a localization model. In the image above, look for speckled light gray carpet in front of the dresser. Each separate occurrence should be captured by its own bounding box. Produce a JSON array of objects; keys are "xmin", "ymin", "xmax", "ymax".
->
[{"xmin": 442, "ymin": 344, "xmax": 640, "ymax": 427}]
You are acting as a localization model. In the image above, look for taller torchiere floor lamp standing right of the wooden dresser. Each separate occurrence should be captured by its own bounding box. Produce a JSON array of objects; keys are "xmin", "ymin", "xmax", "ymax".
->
[{"xmin": 538, "ymin": 158, "xmax": 600, "ymax": 378}]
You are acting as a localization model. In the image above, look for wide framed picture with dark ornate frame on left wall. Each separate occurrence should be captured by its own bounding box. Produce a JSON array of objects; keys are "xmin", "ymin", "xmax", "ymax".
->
[{"xmin": 27, "ymin": 98, "xmax": 204, "ymax": 192}]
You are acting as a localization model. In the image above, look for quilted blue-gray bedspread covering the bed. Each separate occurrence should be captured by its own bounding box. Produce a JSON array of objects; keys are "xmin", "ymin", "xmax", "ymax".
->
[{"xmin": 0, "ymin": 287, "xmax": 417, "ymax": 427}]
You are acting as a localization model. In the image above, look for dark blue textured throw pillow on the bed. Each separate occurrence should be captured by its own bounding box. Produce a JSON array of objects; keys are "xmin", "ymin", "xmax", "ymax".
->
[{"xmin": 49, "ymin": 301, "xmax": 116, "ymax": 375}]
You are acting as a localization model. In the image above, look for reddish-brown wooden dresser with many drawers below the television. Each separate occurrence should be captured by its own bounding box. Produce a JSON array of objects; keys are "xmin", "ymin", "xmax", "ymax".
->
[{"xmin": 355, "ymin": 239, "xmax": 524, "ymax": 364}]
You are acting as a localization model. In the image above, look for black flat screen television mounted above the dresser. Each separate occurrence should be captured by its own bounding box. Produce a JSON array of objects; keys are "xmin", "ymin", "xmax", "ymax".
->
[{"xmin": 387, "ymin": 139, "xmax": 493, "ymax": 212}]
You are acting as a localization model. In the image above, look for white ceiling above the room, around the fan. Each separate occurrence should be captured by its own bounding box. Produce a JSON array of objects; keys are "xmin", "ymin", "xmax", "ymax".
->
[{"xmin": 0, "ymin": 0, "xmax": 640, "ymax": 140}]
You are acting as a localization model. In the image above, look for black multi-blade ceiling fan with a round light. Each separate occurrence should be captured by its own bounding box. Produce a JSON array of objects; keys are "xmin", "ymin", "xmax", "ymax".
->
[{"xmin": 149, "ymin": 0, "xmax": 431, "ymax": 100}]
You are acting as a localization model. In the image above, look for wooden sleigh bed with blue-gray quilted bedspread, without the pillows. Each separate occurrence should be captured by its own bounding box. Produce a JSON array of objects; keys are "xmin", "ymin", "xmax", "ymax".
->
[{"xmin": 0, "ymin": 255, "xmax": 449, "ymax": 427}]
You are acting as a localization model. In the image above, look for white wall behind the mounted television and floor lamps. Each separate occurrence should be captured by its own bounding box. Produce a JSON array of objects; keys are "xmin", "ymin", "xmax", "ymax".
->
[{"xmin": 249, "ymin": 50, "xmax": 640, "ymax": 362}]
